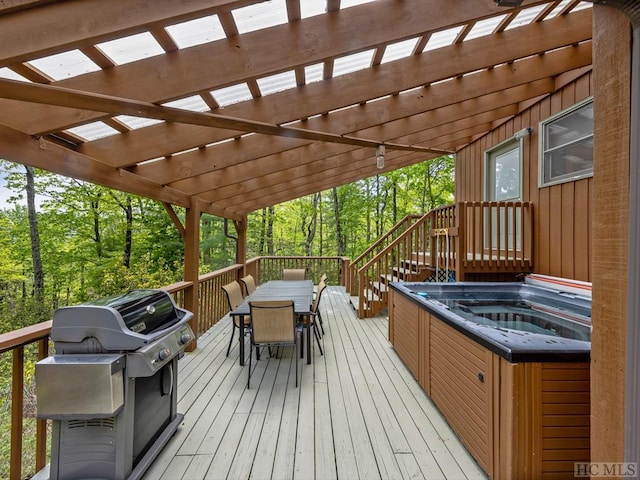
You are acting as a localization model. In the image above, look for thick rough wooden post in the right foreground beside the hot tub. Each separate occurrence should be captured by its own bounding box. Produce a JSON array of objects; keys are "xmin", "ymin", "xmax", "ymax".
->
[{"xmin": 591, "ymin": 5, "xmax": 637, "ymax": 462}]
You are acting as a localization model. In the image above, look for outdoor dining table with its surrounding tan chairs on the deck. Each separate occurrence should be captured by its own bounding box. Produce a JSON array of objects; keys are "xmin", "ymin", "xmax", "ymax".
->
[{"xmin": 222, "ymin": 269, "xmax": 327, "ymax": 388}]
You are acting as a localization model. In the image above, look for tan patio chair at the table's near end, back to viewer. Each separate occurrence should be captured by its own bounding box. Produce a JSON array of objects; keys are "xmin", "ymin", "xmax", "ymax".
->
[{"xmin": 247, "ymin": 300, "xmax": 298, "ymax": 389}]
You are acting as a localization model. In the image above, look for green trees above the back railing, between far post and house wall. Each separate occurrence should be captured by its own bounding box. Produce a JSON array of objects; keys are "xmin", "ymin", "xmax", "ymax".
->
[{"xmin": 247, "ymin": 157, "xmax": 454, "ymax": 258}]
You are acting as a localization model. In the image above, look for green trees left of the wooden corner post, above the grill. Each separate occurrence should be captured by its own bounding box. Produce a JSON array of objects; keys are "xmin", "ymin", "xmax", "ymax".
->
[{"xmin": 0, "ymin": 162, "xmax": 184, "ymax": 318}]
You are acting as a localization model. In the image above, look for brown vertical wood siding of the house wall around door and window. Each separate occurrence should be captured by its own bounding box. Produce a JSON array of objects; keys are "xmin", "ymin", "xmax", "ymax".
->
[{"xmin": 456, "ymin": 72, "xmax": 593, "ymax": 281}]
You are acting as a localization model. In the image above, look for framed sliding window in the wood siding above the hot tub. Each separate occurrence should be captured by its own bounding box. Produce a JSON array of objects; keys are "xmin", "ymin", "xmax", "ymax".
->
[{"xmin": 538, "ymin": 99, "xmax": 593, "ymax": 187}]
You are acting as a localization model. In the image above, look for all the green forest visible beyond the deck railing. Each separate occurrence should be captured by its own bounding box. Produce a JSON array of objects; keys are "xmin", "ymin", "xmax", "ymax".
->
[{"xmin": 0, "ymin": 156, "xmax": 454, "ymax": 478}]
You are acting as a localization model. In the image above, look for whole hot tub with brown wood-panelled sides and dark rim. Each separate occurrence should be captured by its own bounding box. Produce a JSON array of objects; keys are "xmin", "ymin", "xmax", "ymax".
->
[{"xmin": 389, "ymin": 276, "xmax": 591, "ymax": 479}]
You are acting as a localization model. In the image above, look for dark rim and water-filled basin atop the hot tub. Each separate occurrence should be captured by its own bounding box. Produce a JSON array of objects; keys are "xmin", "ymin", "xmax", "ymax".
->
[{"xmin": 392, "ymin": 282, "xmax": 591, "ymax": 362}]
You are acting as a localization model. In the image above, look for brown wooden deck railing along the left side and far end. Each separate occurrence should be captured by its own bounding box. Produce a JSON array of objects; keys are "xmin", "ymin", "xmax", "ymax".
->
[{"xmin": 0, "ymin": 257, "xmax": 349, "ymax": 480}]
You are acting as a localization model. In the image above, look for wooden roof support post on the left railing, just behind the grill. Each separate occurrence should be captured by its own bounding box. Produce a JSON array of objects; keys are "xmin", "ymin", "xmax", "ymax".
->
[{"xmin": 184, "ymin": 199, "xmax": 201, "ymax": 352}]
